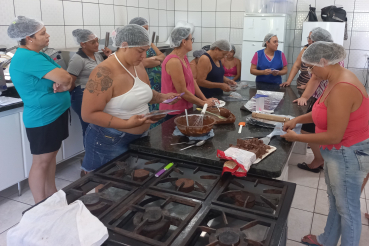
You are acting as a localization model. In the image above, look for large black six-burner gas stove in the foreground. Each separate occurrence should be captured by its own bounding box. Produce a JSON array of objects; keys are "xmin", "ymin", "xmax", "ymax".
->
[{"xmin": 30, "ymin": 151, "xmax": 296, "ymax": 246}]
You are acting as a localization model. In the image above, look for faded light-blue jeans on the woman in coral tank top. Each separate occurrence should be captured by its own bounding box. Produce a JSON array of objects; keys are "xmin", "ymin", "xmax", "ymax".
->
[{"xmin": 317, "ymin": 140, "xmax": 369, "ymax": 246}]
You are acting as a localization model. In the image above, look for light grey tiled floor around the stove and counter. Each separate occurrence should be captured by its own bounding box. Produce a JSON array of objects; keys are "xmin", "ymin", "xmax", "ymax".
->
[{"xmin": 0, "ymin": 153, "xmax": 369, "ymax": 246}]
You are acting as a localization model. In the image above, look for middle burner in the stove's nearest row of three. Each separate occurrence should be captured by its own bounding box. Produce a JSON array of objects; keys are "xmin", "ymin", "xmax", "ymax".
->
[{"xmin": 133, "ymin": 207, "xmax": 170, "ymax": 240}]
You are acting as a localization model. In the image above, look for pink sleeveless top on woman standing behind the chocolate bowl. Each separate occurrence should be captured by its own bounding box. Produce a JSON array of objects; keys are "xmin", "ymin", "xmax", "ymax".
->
[{"xmin": 159, "ymin": 55, "xmax": 195, "ymax": 115}]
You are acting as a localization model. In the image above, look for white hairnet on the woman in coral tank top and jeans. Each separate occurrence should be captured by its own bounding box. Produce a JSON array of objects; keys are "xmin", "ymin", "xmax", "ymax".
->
[{"xmin": 301, "ymin": 41, "xmax": 346, "ymax": 67}]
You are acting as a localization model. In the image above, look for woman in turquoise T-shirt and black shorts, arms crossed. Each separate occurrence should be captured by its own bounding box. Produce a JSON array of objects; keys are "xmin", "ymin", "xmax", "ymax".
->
[{"xmin": 8, "ymin": 16, "xmax": 72, "ymax": 203}]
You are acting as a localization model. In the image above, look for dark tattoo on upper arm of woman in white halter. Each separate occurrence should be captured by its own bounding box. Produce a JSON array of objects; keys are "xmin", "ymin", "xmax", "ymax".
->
[{"xmin": 86, "ymin": 67, "xmax": 113, "ymax": 95}]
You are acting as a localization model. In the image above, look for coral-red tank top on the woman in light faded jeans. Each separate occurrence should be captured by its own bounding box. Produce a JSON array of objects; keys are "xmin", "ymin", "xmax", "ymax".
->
[{"xmin": 312, "ymin": 82, "xmax": 369, "ymax": 150}]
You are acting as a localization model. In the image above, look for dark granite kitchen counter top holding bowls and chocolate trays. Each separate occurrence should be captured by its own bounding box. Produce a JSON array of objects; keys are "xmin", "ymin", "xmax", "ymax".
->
[{"xmin": 130, "ymin": 82, "xmax": 307, "ymax": 178}]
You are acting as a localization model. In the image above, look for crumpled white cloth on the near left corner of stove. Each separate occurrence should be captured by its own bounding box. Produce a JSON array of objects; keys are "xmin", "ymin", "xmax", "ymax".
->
[{"xmin": 7, "ymin": 190, "xmax": 109, "ymax": 246}]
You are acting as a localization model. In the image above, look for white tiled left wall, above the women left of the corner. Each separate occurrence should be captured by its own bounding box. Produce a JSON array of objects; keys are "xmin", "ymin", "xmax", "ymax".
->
[{"xmin": 0, "ymin": 0, "xmax": 175, "ymax": 48}]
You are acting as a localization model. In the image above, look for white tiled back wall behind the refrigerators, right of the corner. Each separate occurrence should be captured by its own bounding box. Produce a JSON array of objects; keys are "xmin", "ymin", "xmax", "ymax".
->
[{"xmin": 180, "ymin": 0, "xmax": 369, "ymax": 82}]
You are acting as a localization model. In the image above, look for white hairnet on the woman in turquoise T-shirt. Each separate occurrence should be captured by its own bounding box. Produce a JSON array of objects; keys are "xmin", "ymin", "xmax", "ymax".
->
[{"xmin": 8, "ymin": 16, "xmax": 44, "ymax": 41}]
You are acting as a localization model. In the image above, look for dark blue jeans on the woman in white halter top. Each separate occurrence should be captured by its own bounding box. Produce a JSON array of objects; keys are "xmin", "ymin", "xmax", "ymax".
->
[{"xmin": 82, "ymin": 124, "xmax": 148, "ymax": 172}]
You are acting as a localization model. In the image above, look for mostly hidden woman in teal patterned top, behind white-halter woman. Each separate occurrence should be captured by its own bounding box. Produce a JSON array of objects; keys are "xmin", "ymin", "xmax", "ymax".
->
[{"xmin": 129, "ymin": 17, "xmax": 165, "ymax": 128}]
